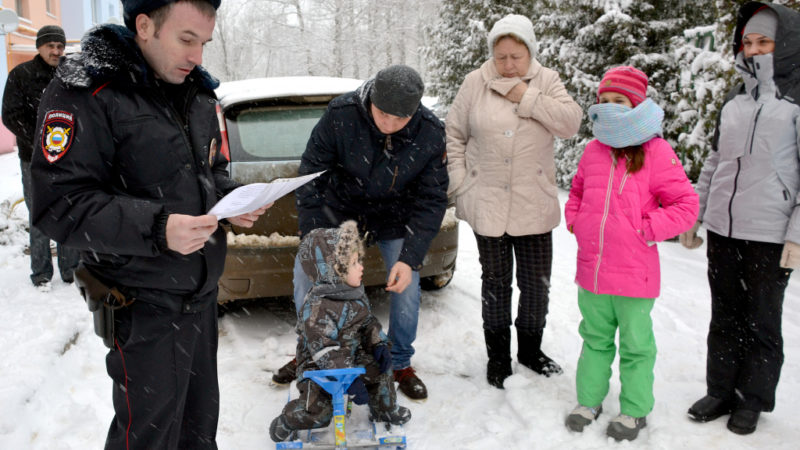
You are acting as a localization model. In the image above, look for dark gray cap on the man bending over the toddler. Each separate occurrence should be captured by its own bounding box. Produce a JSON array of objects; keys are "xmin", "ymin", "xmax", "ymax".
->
[{"xmin": 369, "ymin": 65, "xmax": 425, "ymax": 117}]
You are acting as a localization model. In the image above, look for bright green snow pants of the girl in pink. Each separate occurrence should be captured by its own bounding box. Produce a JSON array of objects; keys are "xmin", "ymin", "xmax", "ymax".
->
[{"xmin": 575, "ymin": 287, "xmax": 656, "ymax": 417}]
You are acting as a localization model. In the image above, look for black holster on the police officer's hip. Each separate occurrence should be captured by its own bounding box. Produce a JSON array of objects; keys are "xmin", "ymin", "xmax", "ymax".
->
[{"xmin": 75, "ymin": 263, "xmax": 134, "ymax": 349}]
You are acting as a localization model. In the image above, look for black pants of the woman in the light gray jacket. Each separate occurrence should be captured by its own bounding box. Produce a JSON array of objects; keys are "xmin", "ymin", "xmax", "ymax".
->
[{"xmin": 706, "ymin": 231, "xmax": 792, "ymax": 411}]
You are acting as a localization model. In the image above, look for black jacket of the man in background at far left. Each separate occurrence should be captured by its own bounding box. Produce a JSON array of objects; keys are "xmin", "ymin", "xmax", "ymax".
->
[{"xmin": 3, "ymin": 55, "xmax": 56, "ymax": 162}]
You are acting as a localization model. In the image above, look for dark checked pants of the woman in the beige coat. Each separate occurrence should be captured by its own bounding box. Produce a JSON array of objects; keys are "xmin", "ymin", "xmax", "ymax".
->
[{"xmin": 475, "ymin": 233, "xmax": 553, "ymax": 335}]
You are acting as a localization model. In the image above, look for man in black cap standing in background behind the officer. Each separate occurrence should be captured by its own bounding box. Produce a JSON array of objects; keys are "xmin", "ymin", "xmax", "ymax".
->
[{"xmin": 3, "ymin": 25, "xmax": 79, "ymax": 286}]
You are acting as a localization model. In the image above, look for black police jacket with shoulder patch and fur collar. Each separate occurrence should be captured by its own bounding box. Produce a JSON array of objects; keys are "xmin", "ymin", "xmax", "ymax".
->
[{"xmin": 32, "ymin": 25, "xmax": 238, "ymax": 312}]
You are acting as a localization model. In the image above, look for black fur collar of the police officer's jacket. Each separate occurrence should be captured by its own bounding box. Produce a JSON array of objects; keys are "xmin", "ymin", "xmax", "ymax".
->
[{"xmin": 56, "ymin": 25, "xmax": 219, "ymax": 92}]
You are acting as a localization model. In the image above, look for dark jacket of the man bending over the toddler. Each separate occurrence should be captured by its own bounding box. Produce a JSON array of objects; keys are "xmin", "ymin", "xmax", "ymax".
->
[{"xmin": 296, "ymin": 80, "xmax": 448, "ymax": 270}]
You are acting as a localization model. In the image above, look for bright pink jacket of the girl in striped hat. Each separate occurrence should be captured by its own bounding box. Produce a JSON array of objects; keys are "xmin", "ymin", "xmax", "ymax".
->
[{"xmin": 564, "ymin": 138, "xmax": 699, "ymax": 298}]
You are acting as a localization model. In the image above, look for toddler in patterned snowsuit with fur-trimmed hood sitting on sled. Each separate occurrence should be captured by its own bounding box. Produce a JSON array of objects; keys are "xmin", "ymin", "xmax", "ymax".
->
[{"xmin": 269, "ymin": 220, "xmax": 411, "ymax": 442}]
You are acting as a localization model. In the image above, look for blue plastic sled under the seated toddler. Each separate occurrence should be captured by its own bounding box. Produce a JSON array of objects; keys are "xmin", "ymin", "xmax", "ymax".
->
[{"xmin": 275, "ymin": 367, "xmax": 406, "ymax": 450}]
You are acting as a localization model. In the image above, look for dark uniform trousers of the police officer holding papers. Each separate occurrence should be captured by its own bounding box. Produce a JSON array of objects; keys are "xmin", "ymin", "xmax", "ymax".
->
[{"xmin": 105, "ymin": 301, "xmax": 219, "ymax": 449}]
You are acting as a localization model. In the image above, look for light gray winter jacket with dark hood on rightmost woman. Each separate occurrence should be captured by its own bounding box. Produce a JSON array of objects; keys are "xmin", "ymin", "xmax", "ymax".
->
[{"xmin": 696, "ymin": 2, "xmax": 800, "ymax": 244}]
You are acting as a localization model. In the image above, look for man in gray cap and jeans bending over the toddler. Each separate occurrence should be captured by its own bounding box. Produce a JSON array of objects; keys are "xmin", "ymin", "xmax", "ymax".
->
[{"xmin": 273, "ymin": 65, "xmax": 448, "ymax": 400}]
